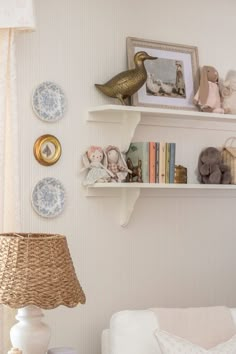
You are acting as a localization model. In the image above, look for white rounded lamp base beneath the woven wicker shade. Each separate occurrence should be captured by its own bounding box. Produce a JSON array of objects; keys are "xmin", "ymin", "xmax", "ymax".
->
[{"xmin": 10, "ymin": 305, "xmax": 51, "ymax": 354}]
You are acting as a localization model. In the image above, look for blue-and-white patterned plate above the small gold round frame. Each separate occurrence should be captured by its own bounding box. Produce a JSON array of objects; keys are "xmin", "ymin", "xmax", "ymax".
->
[{"xmin": 32, "ymin": 81, "xmax": 66, "ymax": 122}]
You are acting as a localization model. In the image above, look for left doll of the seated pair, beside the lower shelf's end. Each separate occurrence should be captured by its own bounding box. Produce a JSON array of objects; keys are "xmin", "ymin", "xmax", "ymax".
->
[{"xmin": 82, "ymin": 146, "xmax": 114, "ymax": 186}]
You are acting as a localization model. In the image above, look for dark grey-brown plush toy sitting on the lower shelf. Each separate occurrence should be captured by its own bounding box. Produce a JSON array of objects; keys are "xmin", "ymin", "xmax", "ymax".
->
[{"xmin": 198, "ymin": 147, "xmax": 231, "ymax": 184}]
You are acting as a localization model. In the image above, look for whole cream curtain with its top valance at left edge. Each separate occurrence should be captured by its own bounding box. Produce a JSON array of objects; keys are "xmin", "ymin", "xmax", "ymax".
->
[{"xmin": 0, "ymin": 0, "xmax": 34, "ymax": 354}]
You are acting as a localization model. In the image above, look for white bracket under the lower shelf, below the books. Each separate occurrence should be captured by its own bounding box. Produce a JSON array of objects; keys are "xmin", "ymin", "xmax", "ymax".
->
[{"xmin": 120, "ymin": 188, "xmax": 140, "ymax": 227}]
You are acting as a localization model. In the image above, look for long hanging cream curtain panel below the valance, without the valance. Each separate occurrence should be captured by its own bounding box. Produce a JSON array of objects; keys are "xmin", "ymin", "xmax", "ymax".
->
[{"xmin": 0, "ymin": 29, "xmax": 20, "ymax": 354}]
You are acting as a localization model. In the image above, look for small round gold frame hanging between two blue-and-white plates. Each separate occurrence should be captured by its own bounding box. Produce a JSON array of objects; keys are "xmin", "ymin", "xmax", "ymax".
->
[{"xmin": 33, "ymin": 134, "xmax": 61, "ymax": 166}]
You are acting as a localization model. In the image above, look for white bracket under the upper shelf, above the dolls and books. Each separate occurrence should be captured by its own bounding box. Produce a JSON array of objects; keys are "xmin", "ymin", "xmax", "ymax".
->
[{"xmin": 120, "ymin": 111, "xmax": 141, "ymax": 152}]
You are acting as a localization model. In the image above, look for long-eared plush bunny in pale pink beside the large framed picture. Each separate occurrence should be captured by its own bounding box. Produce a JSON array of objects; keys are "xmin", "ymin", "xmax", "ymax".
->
[{"xmin": 194, "ymin": 66, "xmax": 224, "ymax": 113}]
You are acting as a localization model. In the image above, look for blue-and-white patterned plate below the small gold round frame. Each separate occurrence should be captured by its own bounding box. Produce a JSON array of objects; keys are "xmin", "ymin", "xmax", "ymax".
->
[{"xmin": 32, "ymin": 177, "xmax": 65, "ymax": 218}]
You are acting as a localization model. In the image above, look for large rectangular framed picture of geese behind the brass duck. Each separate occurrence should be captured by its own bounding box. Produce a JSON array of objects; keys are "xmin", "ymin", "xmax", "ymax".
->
[{"xmin": 127, "ymin": 37, "xmax": 199, "ymax": 110}]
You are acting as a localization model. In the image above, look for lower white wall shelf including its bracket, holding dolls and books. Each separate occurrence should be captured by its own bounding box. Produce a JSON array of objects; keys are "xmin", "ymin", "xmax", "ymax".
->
[{"xmin": 86, "ymin": 183, "xmax": 236, "ymax": 226}]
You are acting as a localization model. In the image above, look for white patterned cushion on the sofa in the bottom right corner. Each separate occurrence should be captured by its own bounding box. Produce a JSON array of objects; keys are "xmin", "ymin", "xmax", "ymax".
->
[{"xmin": 155, "ymin": 330, "xmax": 236, "ymax": 354}]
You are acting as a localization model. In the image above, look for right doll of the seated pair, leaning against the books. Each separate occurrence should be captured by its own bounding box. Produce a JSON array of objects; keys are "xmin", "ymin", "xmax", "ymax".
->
[{"xmin": 105, "ymin": 145, "xmax": 131, "ymax": 182}]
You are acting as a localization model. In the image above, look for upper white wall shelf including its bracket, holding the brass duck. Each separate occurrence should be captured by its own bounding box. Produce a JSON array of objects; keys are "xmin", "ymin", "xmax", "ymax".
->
[{"xmin": 87, "ymin": 105, "xmax": 236, "ymax": 151}]
